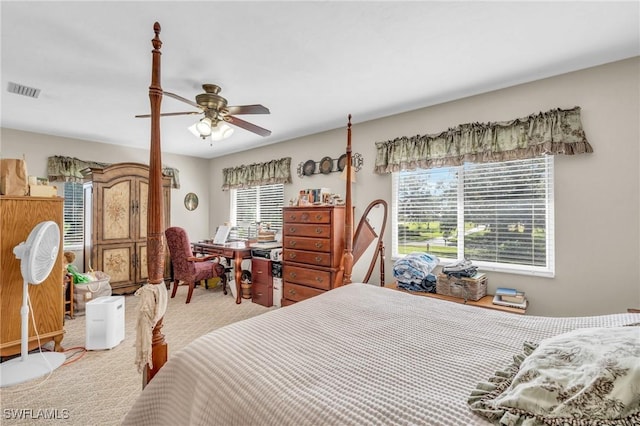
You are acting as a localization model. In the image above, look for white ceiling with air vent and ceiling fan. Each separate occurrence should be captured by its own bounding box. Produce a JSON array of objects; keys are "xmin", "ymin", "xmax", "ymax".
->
[{"xmin": 0, "ymin": 1, "xmax": 640, "ymax": 158}]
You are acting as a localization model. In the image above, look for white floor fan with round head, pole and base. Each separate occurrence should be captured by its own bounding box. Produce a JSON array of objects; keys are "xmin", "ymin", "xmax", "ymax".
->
[{"xmin": 0, "ymin": 221, "xmax": 66, "ymax": 387}]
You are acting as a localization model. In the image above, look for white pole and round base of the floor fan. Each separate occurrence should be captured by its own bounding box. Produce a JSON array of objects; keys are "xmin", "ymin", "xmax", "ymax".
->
[{"xmin": 0, "ymin": 281, "xmax": 67, "ymax": 387}]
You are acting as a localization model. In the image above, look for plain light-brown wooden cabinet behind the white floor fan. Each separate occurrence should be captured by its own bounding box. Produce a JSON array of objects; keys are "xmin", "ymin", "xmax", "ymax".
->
[{"xmin": 0, "ymin": 195, "xmax": 64, "ymax": 357}]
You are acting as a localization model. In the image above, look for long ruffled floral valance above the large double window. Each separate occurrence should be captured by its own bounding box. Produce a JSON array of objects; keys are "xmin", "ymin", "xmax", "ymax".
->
[{"xmin": 375, "ymin": 107, "xmax": 593, "ymax": 174}]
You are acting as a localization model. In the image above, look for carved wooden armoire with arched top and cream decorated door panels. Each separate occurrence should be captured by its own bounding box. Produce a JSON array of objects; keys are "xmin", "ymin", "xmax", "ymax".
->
[{"xmin": 84, "ymin": 163, "xmax": 171, "ymax": 294}]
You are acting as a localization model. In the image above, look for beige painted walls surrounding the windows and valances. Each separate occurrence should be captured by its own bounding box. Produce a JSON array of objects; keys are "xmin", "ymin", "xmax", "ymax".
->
[{"xmin": 1, "ymin": 58, "xmax": 640, "ymax": 316}]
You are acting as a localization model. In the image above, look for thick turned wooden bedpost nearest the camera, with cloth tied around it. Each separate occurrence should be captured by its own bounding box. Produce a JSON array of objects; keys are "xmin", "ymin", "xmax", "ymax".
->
[{"xmin": 142, "ymin": 22, "xmax": 167, "ymax": 387}]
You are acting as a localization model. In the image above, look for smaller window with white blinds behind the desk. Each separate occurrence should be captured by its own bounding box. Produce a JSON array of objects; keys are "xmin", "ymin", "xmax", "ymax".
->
[{"xmin": 229, "ymin": 183, "xmax": 284, "ymax": 239}]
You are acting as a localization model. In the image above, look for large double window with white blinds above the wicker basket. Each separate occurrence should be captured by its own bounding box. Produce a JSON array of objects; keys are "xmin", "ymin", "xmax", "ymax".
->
[{"xmin": 392, "ymin": 156, "xmax": 554, "ymax": 276}]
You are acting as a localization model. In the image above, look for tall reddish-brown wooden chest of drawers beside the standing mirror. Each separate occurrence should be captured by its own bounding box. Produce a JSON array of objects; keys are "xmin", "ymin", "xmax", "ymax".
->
[{"xmin": 282, "ymin": 206, "xmax": 345, "ymax": 306}]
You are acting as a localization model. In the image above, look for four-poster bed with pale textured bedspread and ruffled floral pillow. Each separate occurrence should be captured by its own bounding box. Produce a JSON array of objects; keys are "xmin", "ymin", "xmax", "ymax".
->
[{"xmin": 131, "ymin": 26, "xmax": 640, "ymax": 425}]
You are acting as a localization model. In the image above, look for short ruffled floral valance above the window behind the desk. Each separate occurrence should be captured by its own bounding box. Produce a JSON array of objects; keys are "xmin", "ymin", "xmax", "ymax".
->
[{"xmin": 222, "ymin": 157, "xmax": 291, "ymax": 191}]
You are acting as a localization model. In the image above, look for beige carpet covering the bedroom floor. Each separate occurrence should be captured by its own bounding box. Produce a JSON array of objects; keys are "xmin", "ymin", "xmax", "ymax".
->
[{"xmin": 0, "ymin": 287, "xmax": 275, "ymax": 426}]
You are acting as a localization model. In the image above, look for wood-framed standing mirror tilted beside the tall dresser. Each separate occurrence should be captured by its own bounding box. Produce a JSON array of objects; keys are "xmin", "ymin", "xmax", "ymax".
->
[{"xmin": 352, "ymin": 200, "xmax": 387, "ymax": 286}]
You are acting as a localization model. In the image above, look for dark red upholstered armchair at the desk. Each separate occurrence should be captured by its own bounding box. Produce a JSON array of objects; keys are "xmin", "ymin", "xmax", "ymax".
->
[{"xmin": 164, "ymin": 226, "xmax": 227, "ymax": 303}]
